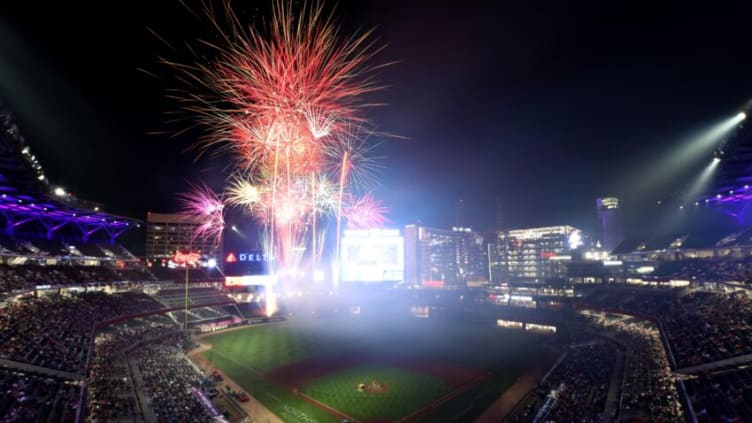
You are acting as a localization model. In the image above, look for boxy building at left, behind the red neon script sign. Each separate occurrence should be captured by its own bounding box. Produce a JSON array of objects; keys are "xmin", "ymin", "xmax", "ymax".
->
[{"xmin": 146, "ymin": 212, "xmax": 221, "ymax": 257}]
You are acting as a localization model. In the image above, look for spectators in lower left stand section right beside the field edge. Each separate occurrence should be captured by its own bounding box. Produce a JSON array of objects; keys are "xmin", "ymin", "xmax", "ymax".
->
[{"xmin": 132, "ymin": 333, "xmax": 213, "ymax": 423}]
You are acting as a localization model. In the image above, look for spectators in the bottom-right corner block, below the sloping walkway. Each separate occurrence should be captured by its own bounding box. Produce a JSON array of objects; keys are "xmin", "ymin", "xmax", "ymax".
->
[{"xmin": 683, "ymin": 367, "xmax": 752, "ymax": 423}]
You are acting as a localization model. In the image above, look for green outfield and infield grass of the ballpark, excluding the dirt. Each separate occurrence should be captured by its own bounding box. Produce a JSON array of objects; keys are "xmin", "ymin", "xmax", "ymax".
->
[{"xmin": 204, "ymin": 318, "xmax": 541, "ymax": 423}]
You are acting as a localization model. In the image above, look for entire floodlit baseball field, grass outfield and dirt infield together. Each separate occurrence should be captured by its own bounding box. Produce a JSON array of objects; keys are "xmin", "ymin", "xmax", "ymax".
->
[{"xmin": 203, "ymin": 316, "xmax": 545, "ymax": 423}]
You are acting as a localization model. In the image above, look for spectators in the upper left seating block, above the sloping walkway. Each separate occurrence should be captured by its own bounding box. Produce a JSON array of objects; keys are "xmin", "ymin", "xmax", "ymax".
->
[{"xmin": 0, "ymin": 292, "xmax": 163, "ymax": 374}]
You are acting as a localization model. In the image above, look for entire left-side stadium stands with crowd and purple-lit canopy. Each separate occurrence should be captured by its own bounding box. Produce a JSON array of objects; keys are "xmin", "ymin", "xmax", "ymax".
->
[{"xmin": 0, "ymin": 97, "xmax": 240, "ymax": 423}]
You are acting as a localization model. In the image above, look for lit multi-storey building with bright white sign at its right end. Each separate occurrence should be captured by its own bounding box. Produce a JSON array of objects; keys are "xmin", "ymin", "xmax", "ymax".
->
[{"xmin": 489, "ymin": 225, "xmax": 582, "ymax": 283}]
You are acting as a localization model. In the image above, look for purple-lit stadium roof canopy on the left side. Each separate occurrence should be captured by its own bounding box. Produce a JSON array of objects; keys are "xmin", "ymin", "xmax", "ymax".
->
[{"xmin": 0, "ymin": 98, "xmax": 140, "ymax": 242}]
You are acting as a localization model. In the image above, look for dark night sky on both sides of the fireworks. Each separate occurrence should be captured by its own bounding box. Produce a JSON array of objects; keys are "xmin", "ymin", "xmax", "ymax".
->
[{"xmin": 0, "ymin": 0, "xmax": 752, "ymax": 240}]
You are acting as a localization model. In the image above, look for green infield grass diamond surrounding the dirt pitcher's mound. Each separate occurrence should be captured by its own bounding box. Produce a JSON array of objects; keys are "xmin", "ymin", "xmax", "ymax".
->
[{"xmin": 303, "ymin": 366, "xmax": 449, "ymax": 420}]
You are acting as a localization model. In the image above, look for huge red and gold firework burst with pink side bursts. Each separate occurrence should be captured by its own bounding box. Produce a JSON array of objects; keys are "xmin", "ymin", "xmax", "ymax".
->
[{"xmin": 163, "ymin": 0, "xmax": 385, "ymax": 284}]
